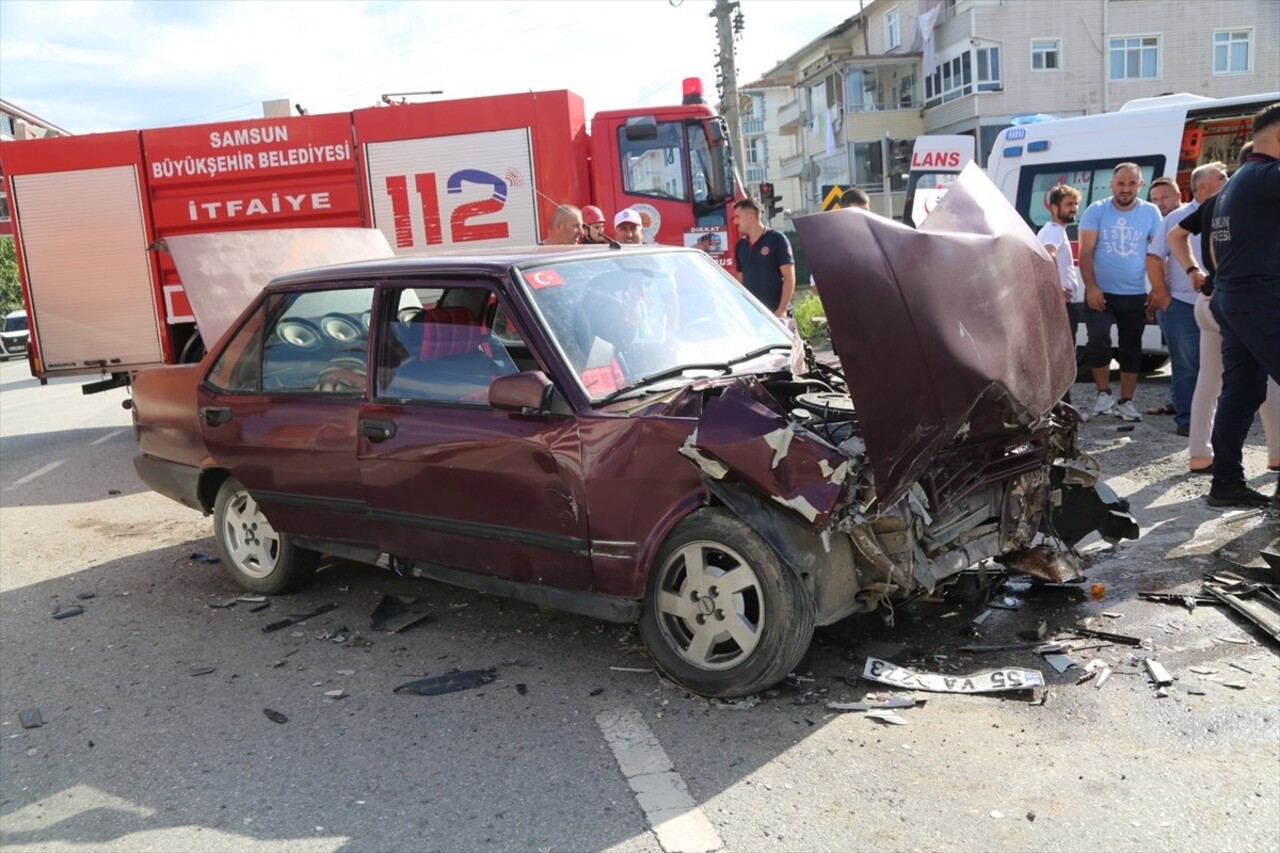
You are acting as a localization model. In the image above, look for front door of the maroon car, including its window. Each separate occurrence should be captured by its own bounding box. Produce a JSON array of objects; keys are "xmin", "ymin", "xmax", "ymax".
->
[{"xmin": 357, "ymin": 280, "xmax": 591, "ymax": 589}]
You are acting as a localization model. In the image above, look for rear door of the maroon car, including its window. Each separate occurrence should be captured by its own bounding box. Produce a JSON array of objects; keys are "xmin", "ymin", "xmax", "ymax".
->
[{"xmin": 198, "ymin": 284, "xmax": 375, "ymax": 543}]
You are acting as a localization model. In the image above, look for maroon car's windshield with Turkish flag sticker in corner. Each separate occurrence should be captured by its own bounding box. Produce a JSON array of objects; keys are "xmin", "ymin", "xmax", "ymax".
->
[{"xmin": 521, "ymin": 251, "xmax": 791, "ymax": 401}]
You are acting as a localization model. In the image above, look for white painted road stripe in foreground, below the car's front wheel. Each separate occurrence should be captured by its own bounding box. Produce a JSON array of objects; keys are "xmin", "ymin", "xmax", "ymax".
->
[{"xmin": 595, "ymin": 710, "xmax": 723, "ymax": 853}]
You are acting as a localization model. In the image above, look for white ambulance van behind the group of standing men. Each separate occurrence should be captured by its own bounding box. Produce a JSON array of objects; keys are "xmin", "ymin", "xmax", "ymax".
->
[{"xmin": 987, "ymin": 92, "xmax": 1280, "ymax": 371}]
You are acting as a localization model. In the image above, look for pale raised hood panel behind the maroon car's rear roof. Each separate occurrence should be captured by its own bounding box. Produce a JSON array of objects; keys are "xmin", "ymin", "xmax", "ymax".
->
[{"xmin": 165, "ymin": 228, "xmax": 393, "ymax": 347}]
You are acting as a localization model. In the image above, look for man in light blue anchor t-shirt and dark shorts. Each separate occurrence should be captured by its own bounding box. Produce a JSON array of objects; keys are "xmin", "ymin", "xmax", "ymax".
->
[{"xmin": 1079, "ymin": 163, "xmax": 1164, "ymax": 420}]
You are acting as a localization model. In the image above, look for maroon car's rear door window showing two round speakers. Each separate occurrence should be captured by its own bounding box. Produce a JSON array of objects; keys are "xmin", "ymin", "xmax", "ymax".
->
[{"xmin": 261, "ymin": 287, "xmax": 374, "ymax": 394}]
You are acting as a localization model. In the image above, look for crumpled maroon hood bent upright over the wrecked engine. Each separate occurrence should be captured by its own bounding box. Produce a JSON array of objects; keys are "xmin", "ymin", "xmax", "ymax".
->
[{"xmin": 796, "ymin": 164, "xmax": 1075, "ymax": 503}]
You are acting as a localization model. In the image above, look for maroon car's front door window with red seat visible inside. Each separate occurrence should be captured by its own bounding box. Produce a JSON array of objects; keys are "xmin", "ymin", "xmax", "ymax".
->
[{"xmin": 376, "ymin": 282, "xmax": 532, "ymax": 405}]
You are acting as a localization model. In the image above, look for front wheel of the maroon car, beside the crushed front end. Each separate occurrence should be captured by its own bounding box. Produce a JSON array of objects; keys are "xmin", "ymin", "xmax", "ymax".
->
[{"xmin": 640, "ymin": 507, "xmax": 814, "ymax": 699}]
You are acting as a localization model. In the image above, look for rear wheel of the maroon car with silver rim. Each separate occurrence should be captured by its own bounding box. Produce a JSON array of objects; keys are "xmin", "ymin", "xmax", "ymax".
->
[{"xmin": 214, "ymin": 478, "xmax": 320, "ymax": 596}]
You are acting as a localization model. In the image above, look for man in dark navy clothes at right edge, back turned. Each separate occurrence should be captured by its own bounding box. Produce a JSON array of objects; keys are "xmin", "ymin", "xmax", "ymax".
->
[{"xmin": 1208, "ymin": 104, "xmax": 1280, "ymax": 506}]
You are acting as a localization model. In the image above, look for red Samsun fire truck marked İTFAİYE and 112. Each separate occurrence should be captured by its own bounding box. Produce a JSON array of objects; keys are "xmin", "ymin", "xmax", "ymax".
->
[{"xmin": 0, "ymin": 81, "xmax": 741, "ymax": 393}]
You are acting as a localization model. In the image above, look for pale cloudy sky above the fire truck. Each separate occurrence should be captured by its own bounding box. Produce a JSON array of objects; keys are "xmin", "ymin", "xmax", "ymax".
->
[{"xmin": 0, "ymin": 0, "xmax": 858, "ymax": 133}]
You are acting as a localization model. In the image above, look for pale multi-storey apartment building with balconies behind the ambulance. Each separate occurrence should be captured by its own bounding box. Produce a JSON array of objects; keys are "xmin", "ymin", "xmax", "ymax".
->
[{"xmin": 748, "ymin": 0, "xmax": 1280, "ymax": 222}]
